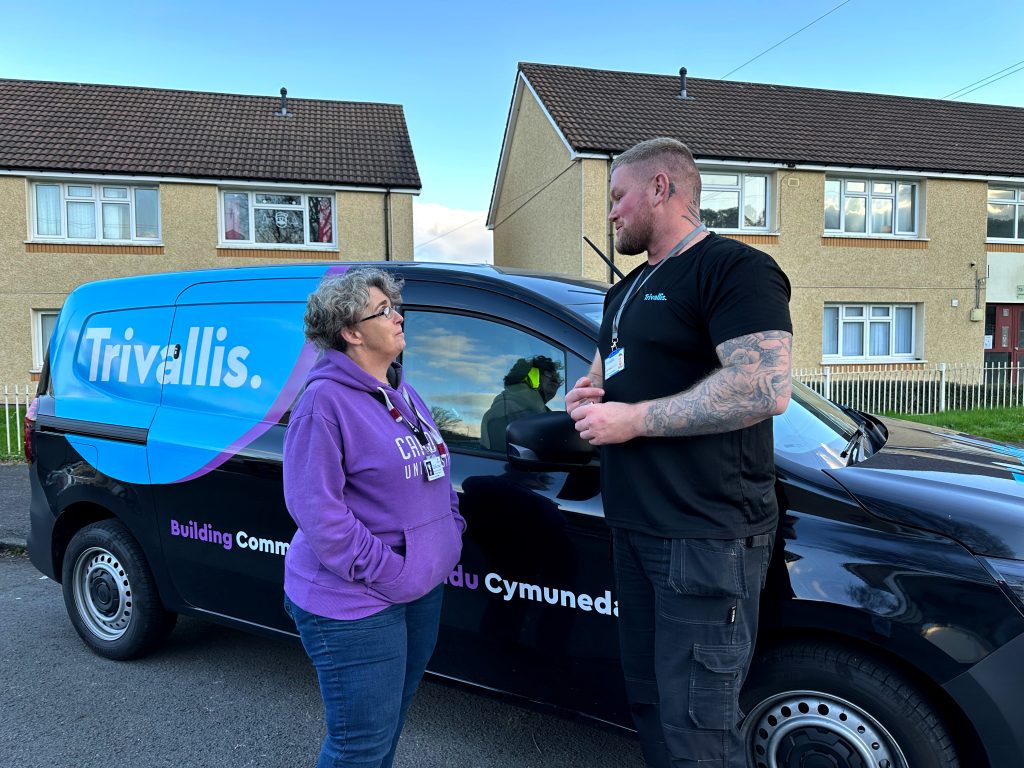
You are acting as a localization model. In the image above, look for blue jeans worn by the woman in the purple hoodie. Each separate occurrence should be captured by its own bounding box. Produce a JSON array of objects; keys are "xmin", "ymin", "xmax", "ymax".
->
[{"xmin": 285, "ymin": 585, "xmax": 444, "ymax": 768}]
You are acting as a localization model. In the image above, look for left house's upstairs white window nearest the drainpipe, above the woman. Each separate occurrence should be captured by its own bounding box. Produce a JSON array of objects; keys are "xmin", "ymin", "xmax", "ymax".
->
[{"xmin": 220, "ymin": 189, "xmax": 337, "ymax": 249}]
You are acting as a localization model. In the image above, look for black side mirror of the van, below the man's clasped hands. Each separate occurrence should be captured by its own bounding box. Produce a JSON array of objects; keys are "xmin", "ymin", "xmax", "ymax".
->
[{"xmin": 505, "ymin": 411, "xmax": 597, "ymax": 471}]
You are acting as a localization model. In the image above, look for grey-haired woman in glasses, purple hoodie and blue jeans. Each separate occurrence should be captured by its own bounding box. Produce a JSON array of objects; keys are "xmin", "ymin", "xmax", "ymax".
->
[{"xmin": 285, "ymin": 268, "xmax": 466, "ymax": 768}]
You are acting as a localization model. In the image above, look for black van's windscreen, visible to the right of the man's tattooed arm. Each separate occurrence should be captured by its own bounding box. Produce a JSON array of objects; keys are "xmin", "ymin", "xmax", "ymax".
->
[{"xmin": 773, "ymin": 381, "xmax": 857, "ymax": 469}]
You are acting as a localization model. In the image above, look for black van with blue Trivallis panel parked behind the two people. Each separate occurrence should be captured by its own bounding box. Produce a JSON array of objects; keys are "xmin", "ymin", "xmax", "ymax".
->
[{"xmin": 27, "ymin": 264, "xmax": 1024, "ymax": 768}]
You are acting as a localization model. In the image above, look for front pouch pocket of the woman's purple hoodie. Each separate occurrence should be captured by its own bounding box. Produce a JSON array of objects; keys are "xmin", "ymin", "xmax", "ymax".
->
[{"xmin": 367, "ymin": 511, "xmax": 462, "ymax": 603}]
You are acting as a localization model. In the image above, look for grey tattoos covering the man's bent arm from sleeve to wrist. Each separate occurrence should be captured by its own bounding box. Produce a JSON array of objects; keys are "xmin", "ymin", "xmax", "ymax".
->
[{"xmin": 644, "ymin": 331, "xmax": 793, "ymax": 437}]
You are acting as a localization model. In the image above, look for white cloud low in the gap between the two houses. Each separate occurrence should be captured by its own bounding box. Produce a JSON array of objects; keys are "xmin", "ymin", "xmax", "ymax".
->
[{"xmin": 413, "ymin": 201, "xmax": 494, "ymax": 264}]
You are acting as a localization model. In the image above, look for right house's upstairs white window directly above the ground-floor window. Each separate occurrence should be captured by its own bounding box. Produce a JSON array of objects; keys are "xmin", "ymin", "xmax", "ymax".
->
[{"xmin": 824, "ymin": 178, "xmax": 921, "ymax": 238}]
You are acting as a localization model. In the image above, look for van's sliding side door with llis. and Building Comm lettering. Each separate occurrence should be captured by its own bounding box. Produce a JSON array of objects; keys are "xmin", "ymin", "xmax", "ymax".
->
[{"xmin": 150, "ymin": 279, "xmax": 317, "ymax": 632}]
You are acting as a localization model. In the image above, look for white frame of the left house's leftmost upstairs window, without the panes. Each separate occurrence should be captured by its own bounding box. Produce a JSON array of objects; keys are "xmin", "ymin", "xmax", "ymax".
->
[{"xmin": 29, "ymin": 178, "xmax": 163, "ymax": 246}]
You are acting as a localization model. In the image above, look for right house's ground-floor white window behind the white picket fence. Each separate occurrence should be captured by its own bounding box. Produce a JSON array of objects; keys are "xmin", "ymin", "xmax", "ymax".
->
[{"xmin": 821, "ymin": 303, "xmax": 920, "ymax": 362}]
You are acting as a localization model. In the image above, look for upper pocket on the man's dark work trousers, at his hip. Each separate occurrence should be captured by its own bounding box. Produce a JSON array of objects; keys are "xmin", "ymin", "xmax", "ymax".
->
[{"xmin": 669, "ymin": 539, "xmax": 748, "ymax": 598}]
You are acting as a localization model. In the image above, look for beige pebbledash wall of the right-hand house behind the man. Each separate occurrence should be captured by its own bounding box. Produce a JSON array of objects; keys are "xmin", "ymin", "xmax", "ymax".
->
[{"xmin": 494, "ymin": 89, "xmax": 987, "ymax": 368}]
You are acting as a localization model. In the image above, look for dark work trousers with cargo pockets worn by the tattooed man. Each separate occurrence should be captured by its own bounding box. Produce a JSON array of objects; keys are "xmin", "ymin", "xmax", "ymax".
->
[{"xmin": 612, "ymin": 528, "xmax": 773, "ymax": 768}]
